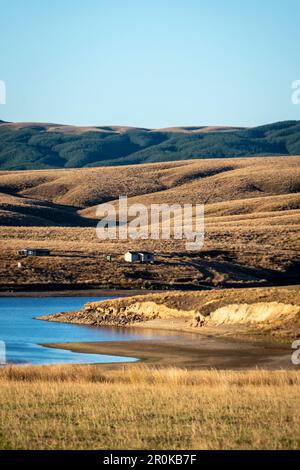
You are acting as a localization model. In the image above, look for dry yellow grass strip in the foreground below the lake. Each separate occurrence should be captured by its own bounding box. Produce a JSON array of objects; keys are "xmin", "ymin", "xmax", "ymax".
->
[{"xmin": 0, "ymin": 366, "xmax": 300, "ymax": 449}]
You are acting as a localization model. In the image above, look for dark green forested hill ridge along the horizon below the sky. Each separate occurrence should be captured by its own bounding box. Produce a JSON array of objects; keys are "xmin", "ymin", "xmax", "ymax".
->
[{"xmin": 0, "ymin": 120, "xmax": 300, "ymax": 170}]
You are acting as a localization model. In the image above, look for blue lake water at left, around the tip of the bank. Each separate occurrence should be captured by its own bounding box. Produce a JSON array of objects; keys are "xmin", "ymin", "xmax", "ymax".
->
[{"xmin": 0, "ymin": 297, "xmax": 154, "ymax": 364}]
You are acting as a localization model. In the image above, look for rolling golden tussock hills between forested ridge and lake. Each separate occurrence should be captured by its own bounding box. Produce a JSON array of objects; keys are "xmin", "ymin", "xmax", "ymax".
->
[{"xmin": 0, "ymin": 157, "xmax": 300, "ymax": 290}]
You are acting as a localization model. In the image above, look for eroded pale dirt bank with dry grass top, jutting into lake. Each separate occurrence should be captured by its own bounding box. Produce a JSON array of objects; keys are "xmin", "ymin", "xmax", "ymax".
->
[{"xmin": 38, "ymin": 288, "xmax": 300, "ymax": 338}]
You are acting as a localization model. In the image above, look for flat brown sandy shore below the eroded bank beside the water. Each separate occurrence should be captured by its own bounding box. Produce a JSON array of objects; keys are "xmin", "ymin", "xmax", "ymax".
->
[{"xmin": 45, "ymin": 320, "xmax": 295, "ymax": 370}]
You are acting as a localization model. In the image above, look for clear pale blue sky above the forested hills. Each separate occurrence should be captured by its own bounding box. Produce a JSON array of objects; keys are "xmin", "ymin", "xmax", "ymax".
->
[{"xmin": 0, "ymin": 0, "xmax": 300, "ymax": 127}]
